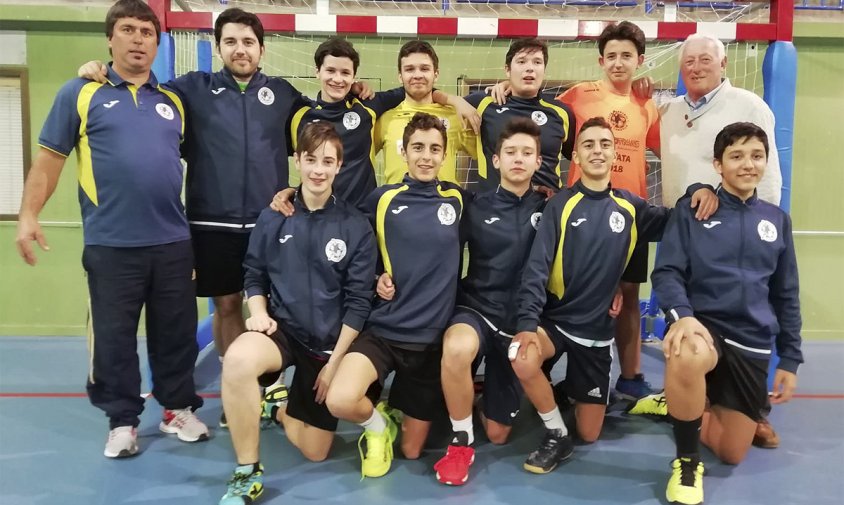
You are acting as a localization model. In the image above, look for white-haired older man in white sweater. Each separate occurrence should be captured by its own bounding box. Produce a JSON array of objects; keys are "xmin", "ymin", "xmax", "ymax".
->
[{"xmin": 660, "ymin": 34, "xmax": 782, "ymax": 207}]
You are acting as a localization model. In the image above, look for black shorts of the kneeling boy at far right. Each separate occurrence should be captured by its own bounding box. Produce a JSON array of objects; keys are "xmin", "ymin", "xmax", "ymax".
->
[{"xmin": 706, "ymin": 326, "xmax": 769, "ymax": 421}]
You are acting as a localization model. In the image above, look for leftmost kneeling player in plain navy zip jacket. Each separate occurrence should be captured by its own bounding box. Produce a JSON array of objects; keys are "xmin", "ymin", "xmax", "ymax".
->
[{"xmin": 220, "ymin": 122, "xmax": 377, "ymax": 505}]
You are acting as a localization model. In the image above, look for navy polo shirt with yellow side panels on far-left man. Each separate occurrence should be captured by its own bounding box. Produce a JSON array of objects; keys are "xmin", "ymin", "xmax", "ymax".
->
[{"xmin": 38, "ymin": 66, "xmax": 190, "ymax": 247}]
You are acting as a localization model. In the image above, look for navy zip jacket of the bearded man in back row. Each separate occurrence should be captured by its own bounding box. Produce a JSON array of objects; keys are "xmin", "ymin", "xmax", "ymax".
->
[{"xmin": 167, "ymin": 69, "xmax": 309, "ymax": 231}]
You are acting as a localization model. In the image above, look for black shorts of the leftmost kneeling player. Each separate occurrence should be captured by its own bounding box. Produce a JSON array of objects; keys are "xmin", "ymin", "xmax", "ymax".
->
[{"xmin": 258, "ymin": 330, "xmax": 337, "ymax": 431}]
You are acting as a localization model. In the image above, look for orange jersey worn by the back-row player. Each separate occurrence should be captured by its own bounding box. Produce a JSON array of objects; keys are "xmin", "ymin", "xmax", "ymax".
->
[{"xmin": 557, "ymin": 81, "xmax": 659, "ymax": 199}]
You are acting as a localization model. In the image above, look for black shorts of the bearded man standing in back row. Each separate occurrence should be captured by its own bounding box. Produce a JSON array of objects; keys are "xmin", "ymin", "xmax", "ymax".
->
[{"xmin": 191, "ymin": 227, "xmax": 249, "ymax": 297}]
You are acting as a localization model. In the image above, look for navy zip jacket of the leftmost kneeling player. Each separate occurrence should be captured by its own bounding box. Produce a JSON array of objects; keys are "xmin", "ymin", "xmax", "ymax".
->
[{"xmin": 243, "ymin": 196, "xmax": 377, "ymax": 352}]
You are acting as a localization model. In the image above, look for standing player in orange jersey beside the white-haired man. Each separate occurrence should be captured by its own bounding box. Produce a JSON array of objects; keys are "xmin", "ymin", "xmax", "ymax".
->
[{"xmin": 557, "ymin": 21, "xmax": 664, "ymax": 400}]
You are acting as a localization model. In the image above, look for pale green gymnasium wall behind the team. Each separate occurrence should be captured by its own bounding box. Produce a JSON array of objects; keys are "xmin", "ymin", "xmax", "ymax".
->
[{"xmin": 0, "ymin": 5, "xmax": 844, "ymax": 339}]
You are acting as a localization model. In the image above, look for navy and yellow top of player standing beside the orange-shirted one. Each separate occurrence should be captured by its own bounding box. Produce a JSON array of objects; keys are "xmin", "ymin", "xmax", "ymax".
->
[{"xmin": 466, "ymin": 92, "xmax": 577, "ymax": 192}]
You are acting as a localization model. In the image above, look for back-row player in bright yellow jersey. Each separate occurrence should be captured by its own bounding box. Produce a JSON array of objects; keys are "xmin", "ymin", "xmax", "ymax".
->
[{"xmin": 374, "ymin": 40, "xmax": 476, "ymax": 184}]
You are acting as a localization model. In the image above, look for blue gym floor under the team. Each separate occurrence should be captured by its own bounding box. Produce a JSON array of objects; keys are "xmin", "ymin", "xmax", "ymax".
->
[{"xmin": 0, "ymin": 337, "xmax": 844, "ymax": 505}]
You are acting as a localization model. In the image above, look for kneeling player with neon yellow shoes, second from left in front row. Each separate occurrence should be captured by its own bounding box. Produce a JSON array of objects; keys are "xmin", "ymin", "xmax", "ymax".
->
[{"xmin": 327, "ymin": 113, "xmax": 463, "ymax": 477}]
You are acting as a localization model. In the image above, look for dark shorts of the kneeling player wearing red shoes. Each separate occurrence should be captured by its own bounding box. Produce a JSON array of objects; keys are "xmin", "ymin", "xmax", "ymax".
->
[{"xmin": 448, "ymin": 307, "xmax": 524, "ymax": 426}]
